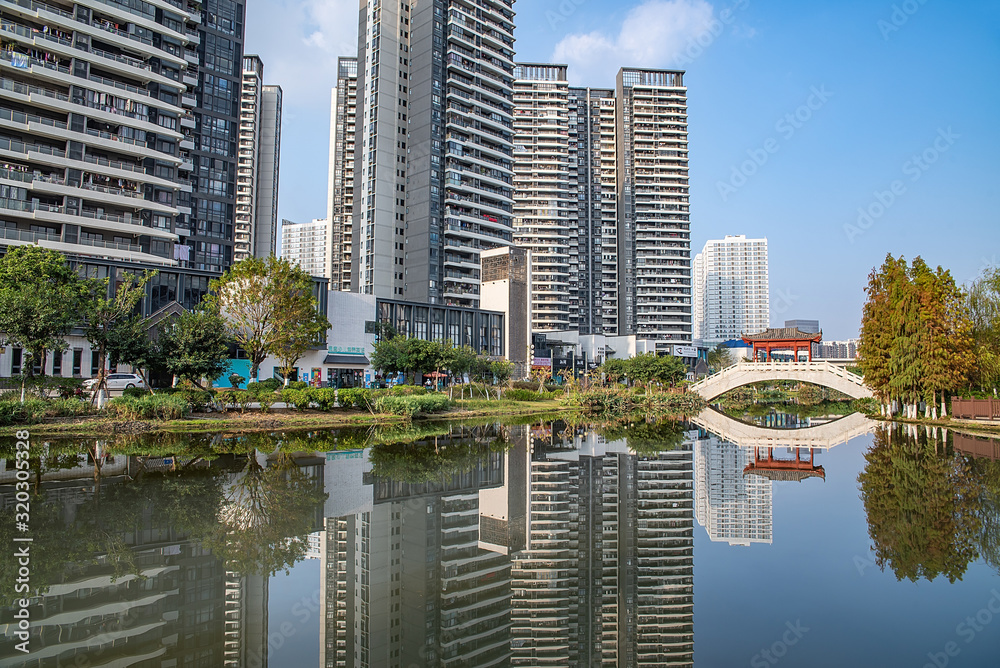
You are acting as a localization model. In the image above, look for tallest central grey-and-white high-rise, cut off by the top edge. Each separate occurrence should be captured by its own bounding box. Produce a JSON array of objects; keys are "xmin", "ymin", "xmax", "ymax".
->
[{"xmin": 351, "ymin": 0, "xmax": 514, "ymax": 306}]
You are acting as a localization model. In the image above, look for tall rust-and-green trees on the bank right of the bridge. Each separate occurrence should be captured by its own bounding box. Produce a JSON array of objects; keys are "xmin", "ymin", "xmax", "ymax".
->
[{"xmin": 858, "ymin": 255, "xmax": 974, "ymax": 417}]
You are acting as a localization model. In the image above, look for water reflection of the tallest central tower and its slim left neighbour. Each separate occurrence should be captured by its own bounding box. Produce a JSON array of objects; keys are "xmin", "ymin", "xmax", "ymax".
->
[{"xmin": 321, "ymin": 429, "xmax": 510, "ymax": 667}]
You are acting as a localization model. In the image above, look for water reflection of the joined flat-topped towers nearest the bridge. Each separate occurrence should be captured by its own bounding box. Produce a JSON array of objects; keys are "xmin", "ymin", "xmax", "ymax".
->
[{"xmin": 511, "ymin": 433, "xmax": 694, "ymax": 666}]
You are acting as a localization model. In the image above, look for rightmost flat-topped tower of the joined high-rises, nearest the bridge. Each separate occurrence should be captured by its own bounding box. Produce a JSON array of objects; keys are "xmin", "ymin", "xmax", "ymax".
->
[{"xmin": 615, "ymin": 68, "xmax": 692, "ymax": 350}]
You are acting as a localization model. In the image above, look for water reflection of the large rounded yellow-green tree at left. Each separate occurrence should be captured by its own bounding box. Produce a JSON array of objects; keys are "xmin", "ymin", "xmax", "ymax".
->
[{"xmin": 203, "ymin": 455, "xmax": 327, "ymax": 577}]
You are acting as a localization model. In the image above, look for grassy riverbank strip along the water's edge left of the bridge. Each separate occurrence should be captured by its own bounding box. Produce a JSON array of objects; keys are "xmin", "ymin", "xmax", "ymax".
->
[{"xmin": 0, "ymin": 399, "xmax": 565, "ymax": 438}]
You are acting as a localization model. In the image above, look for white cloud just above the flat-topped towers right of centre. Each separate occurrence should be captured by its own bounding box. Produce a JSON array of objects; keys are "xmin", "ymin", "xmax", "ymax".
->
[{"xmin": 552, "ymin": 0, "xmax": 721, "ymax": 86}]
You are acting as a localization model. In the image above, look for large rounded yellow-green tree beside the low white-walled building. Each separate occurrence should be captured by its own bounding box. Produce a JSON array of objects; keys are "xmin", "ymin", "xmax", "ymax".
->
[{"xmin": 206, "ymin": 255, "xmax": 329, "ymax": 381}]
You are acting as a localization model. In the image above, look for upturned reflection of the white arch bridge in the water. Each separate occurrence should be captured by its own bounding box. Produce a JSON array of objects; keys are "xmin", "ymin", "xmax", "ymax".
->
[{"xmin": 691, "ymin": 408, "xmax": 876, "ymax": 450}]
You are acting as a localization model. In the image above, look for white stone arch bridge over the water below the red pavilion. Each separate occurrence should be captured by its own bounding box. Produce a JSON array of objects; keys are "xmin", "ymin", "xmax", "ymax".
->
[{"xmin": 688, "ymin": 361, "xmax": 873, "ymax": 400}]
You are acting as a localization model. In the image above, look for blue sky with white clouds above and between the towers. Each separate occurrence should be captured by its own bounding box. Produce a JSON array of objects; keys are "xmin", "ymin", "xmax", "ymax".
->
[{"xmin": 245, "ymin": 0, "xmax": 1000, "ymax": 339}]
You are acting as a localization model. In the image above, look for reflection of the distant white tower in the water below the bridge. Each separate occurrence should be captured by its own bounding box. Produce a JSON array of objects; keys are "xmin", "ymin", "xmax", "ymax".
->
[{"xmin": 694, "ymin": 432, "xmax": 773, "ymax": 545}]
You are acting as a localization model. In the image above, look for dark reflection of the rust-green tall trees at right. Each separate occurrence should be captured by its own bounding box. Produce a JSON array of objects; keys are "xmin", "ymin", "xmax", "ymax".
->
[{"xmin": 858, "ymin": 425, "xmax": 982, "ymax": 582}]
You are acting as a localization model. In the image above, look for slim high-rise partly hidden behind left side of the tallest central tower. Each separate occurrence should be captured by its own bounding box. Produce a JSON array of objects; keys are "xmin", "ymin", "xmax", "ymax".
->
[{"xmin": 326, "ymin": 58, "xmax": 358, "ymax": 292}]
